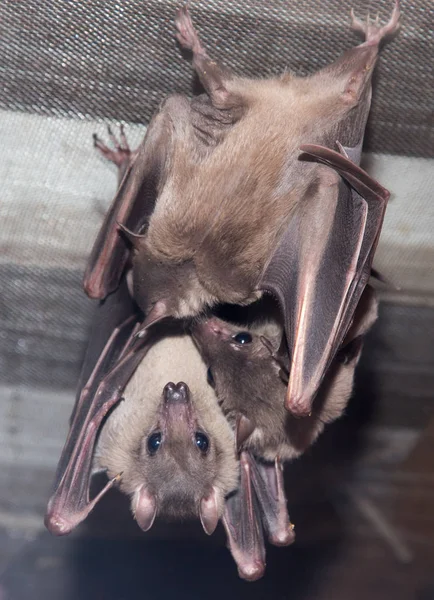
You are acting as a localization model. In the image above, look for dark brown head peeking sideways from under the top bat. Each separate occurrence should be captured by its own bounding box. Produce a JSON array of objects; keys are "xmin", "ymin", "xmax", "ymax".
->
[{"xmin": 192, "ymin": 317, "xmax": 288, "ymax": 458}]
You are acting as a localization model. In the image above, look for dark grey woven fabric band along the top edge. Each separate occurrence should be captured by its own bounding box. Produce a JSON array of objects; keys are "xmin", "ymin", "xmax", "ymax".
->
[{"xmin": 0, "ymin": 0, "xmax": 434, "ymax": 156}]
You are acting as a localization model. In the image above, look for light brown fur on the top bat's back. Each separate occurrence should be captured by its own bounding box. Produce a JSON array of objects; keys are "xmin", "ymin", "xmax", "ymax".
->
[{"xmin": 135, "ymin": 17, "xmax": 386, "ymax": 317}]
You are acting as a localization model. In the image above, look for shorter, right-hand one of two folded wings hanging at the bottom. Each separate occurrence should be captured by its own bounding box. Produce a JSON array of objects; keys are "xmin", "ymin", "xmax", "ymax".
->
[{"xmin": 246, "ymin": 458, "xmax": 295, "ymax": 546}]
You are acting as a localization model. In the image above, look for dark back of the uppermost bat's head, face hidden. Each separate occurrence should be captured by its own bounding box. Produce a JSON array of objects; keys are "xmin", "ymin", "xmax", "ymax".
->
[{"xmin": 133, "ymin": 241, "xmax": 215, "ymax": 327}]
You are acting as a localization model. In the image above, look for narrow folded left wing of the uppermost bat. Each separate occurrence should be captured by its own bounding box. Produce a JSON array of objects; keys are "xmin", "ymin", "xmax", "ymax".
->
[{"xmin": 84, "ymin": 96, "xmax": 186, "ymax": 299}]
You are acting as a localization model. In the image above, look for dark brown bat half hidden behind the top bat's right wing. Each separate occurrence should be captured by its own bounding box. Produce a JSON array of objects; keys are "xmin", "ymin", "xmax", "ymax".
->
[{"xmin": 192, "ymin": 286, "xmax": 378, "ymax": 576}]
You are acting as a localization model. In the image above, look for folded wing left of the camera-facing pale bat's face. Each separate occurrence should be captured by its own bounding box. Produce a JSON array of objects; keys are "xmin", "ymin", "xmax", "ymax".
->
[{"xmin": 45, "ymin": 286, "xmax": 153, "ymax": 535}]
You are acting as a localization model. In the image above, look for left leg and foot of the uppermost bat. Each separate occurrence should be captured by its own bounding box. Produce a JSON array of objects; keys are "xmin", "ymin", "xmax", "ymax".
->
[{"xmin": 175, "ymin": 5, "xmax": 231, "ymax": 108}]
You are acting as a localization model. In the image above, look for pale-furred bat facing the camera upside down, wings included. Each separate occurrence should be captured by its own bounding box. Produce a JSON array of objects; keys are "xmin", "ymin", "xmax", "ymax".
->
[{"xmin": 45, "ymin": 282, "xmax": 289, "ymax": 580}]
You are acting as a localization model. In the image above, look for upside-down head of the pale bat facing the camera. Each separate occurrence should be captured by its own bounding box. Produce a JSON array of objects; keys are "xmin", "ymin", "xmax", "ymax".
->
[{"xmin": 98, "ymin": 382, "xmax": 239, "ymax": 534}]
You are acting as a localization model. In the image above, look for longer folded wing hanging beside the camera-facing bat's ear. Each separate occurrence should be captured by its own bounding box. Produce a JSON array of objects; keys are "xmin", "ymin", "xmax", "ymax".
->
[{"xmin": 223, "ymin": 452, "xmax": 265, "ymax": 581}]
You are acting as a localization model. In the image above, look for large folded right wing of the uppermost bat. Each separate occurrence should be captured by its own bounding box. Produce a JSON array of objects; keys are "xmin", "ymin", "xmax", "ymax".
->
[{"xmin": 260, "ymin": 145, "xmax": 389, "ymax": 415}]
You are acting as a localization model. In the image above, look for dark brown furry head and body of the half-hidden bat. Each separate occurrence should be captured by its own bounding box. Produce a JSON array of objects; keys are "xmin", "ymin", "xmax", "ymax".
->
[{"xmin": 193, "ymin": 287, "xmax": 377, "ymax": 460}]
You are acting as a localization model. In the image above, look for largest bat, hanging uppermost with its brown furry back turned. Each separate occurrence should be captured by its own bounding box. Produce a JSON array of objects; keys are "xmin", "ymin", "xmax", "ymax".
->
[{"xmin": 85, "ymin": 0, "xmax": 400, "ymax": 422}]
